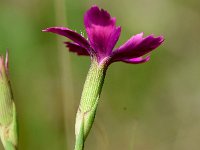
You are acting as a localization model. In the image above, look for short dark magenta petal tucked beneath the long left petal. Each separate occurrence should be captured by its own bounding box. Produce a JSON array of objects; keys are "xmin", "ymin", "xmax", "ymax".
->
[{"xmin": 64, "ymin": 42, "xmax": 90, "ymax": 56}]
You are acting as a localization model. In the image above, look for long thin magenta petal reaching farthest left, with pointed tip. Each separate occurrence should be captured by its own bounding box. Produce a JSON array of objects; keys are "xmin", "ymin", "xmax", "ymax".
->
[{"xmin": 42, "ymin": 27, "xmax": 90, "ymax": 48}]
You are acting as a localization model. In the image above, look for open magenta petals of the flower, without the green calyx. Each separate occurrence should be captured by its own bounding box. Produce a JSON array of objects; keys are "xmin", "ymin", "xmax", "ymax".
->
[{"xmin": 43, "ymin": 6, "xmax": 164, "ymax": 64}]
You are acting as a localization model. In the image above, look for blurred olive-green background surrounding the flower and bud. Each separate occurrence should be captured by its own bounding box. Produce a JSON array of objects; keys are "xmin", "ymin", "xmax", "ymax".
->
[{"xmin": 0, "ymin": 0, "xmax": 200, "ymax": 150}]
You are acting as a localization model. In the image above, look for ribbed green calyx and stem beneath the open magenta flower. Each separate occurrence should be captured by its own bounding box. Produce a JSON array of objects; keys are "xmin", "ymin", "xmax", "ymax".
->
[{"xmin": 75, "ymin": 60, "xmax": 107, "ymax": 150}]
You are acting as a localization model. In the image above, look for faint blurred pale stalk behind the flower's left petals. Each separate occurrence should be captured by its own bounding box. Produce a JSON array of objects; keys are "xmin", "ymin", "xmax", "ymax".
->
[{"xmin": 54, "ymin": 0, "xmax": 75, "ymax": 149}]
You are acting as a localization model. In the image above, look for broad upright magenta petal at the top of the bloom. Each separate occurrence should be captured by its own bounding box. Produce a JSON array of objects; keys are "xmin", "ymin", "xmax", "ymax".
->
[{"xmin": 84, "ymin": 6, "xmax": 121, "ymax": 60}]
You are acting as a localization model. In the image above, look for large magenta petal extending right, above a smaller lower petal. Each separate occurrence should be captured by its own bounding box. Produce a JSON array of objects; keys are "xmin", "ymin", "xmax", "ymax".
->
[{"xmin": 112, "ymin": 33, "xmax": 164, "ymax": 61}]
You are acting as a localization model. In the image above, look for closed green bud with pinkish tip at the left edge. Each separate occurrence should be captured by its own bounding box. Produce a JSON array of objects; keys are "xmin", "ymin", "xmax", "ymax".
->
[{"xmin": 0, "ymin": 53, "xmax": 17, "ymax": 150}]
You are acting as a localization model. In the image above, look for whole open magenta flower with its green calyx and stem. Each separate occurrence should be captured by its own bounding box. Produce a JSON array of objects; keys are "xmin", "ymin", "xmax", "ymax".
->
[{"xmin": 43, "ymin": 6, "xmax": 164, "ymax": 150}]
